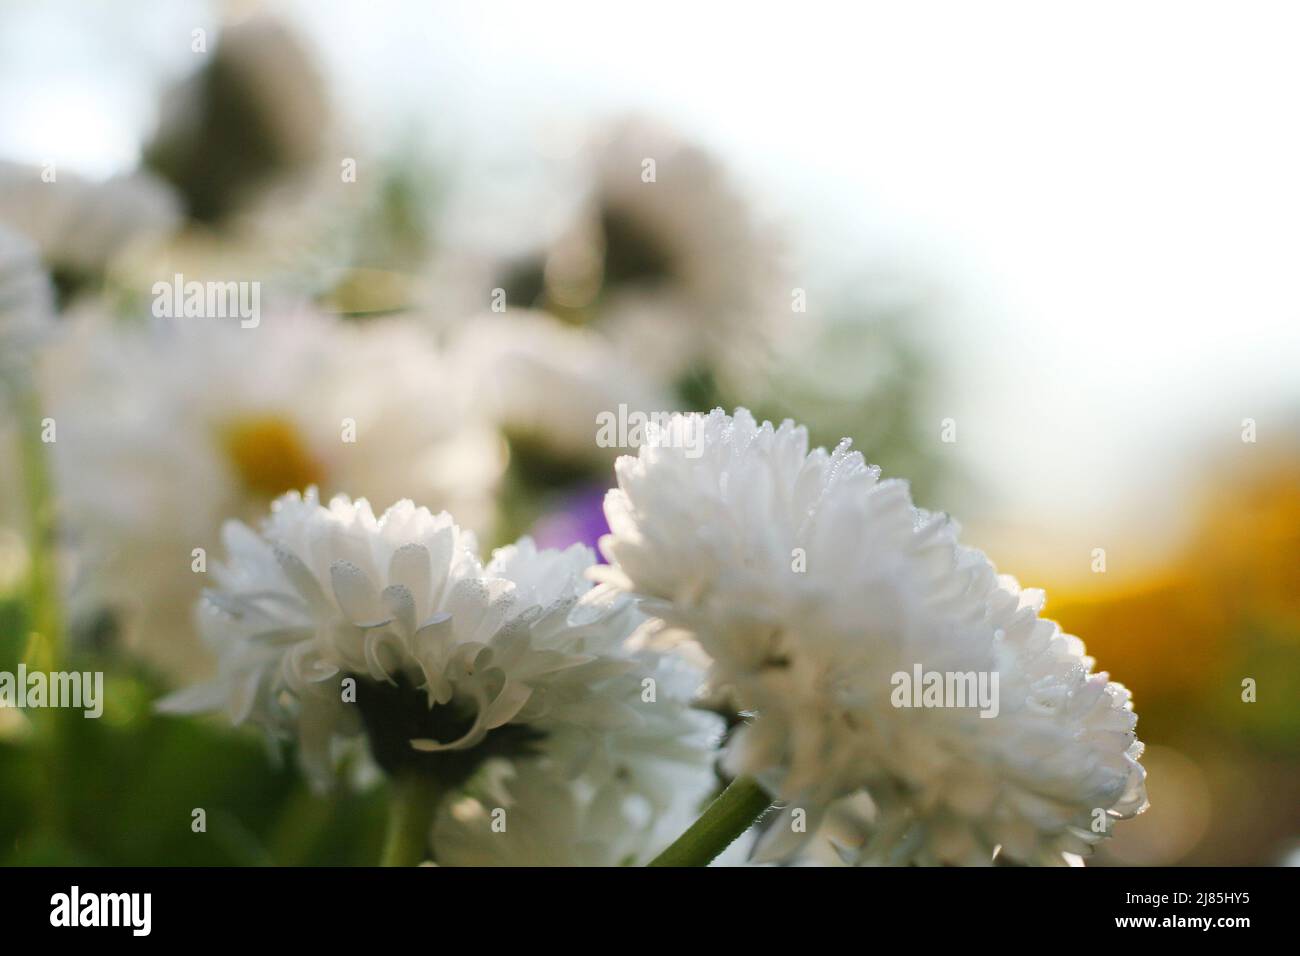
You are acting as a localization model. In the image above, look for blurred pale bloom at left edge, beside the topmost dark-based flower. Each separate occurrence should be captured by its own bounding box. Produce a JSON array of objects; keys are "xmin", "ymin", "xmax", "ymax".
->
[{"xmin": 0, "ymin": 163, "xmax": 181, "ymax": 286}]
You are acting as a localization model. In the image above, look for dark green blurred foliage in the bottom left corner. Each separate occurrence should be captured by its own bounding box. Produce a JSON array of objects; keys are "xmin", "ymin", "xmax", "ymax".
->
[{"xmin": 0, "ymin": 678, "xmax": 384, "ymax": 866}]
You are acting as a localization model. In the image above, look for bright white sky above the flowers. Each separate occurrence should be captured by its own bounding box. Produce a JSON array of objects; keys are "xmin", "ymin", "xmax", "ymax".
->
[{"xmin": 0, "ymin": 0, "xmax": 1300, "ymax": 582}]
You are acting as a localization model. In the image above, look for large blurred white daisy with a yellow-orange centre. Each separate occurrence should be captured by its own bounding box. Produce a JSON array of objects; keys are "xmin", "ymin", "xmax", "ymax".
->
[{"xmin": 43, "ymin": 312, "xmax": 503, "ymax": 680}]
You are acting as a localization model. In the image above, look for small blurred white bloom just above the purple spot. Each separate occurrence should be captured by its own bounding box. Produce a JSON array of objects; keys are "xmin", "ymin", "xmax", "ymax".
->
[{"xmin": 450, "ymin": 310, "xmax": 672, "ymax": 460}]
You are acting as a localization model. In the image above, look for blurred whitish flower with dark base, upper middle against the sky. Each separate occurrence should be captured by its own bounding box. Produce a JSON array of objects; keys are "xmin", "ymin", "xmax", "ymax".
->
[{"xmin": 496, "ymin": 120, "xmax": 790, "ymax": 382}]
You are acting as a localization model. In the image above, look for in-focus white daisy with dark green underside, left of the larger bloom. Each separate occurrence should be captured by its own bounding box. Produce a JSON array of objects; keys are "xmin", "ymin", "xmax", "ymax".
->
[{"xmin": 164, "ymin": 489, "xmax": 712, "ymax": 800}]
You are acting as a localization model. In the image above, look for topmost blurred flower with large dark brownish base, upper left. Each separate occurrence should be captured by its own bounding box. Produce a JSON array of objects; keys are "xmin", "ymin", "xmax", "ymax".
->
[{"xmin": 121, "ymin": 14, "xmax": 361, "ymax": 313}]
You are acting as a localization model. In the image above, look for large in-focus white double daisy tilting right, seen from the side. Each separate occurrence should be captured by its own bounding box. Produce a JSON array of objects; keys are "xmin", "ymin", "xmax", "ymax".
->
[{"xmin": 593, "ymin": 408, "xmax": 1145, "ymax": 864}]
